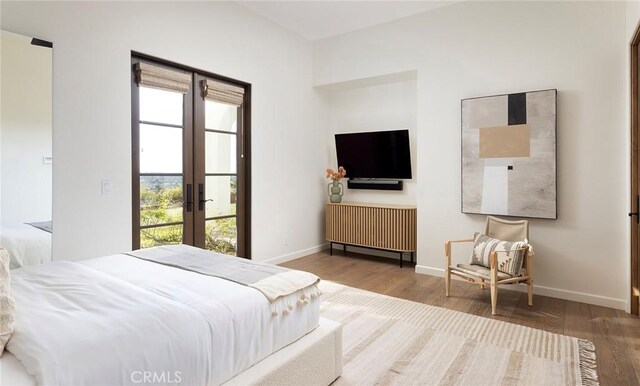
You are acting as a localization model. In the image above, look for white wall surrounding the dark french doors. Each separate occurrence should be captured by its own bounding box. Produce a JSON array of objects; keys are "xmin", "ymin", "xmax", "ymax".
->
[{"xmin": 1, "ymin": 1, "xmax": 327, "ymax": 260}]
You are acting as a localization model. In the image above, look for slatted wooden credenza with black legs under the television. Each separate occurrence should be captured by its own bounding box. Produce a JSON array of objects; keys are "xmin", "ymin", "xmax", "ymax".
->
[{"xmin": 326, "ymin": 202, "xmax": 417, "ymax": 267}]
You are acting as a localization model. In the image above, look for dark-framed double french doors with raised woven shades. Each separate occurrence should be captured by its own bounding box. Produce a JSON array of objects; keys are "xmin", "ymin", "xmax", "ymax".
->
[{"xmin": 131, "ymin": 56, "xmax": 250, "ymax": 258}]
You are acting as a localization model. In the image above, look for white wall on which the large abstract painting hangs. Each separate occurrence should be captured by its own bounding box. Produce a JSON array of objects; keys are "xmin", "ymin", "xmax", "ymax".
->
[{"xmin": 314, "ymin": 2, "xmax": 629, "ymax": 308}]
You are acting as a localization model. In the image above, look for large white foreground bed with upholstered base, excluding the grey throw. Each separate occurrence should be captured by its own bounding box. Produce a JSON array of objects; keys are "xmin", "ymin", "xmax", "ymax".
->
[{"xmin": 0, "ymin": 247, "xmax": 341, "ymax": 386}]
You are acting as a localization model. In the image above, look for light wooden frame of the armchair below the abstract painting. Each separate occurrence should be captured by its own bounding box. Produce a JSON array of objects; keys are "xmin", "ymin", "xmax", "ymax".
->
[{"xmin": 444, "ymin": 218, "xmax": 534, "ymax": 315}]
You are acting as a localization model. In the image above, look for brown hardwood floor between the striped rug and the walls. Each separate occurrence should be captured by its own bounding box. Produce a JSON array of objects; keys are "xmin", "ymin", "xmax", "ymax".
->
[{"xmin": 282, "ymin": 251, "xmax": 640, "ymax": 385}]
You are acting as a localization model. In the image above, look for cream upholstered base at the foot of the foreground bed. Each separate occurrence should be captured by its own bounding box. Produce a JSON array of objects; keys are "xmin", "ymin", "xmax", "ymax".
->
[{"xmin": 224, "ymin": 318, "xmax": 342, "ymax": 386}]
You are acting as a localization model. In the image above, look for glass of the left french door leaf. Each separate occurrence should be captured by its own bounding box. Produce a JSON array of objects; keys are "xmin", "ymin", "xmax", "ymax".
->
[{"xmin": 139, "ymin": 87, "xmax": 185, "ymax": 248}]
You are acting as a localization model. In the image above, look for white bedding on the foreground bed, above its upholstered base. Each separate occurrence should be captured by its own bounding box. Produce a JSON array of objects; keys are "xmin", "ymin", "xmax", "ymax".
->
[{"xmin": 0, "ymin": 254, "xmax": 320, "ymax": 386}]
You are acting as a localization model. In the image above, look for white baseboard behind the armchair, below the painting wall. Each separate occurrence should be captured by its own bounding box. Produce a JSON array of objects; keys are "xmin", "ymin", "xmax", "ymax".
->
[{"xmin": 416, "ymin": 265, "xmax": 627, "ymax": 311}]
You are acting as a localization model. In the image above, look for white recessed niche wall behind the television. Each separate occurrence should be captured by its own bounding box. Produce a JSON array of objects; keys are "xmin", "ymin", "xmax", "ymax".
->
[{"xmin": 326, "ymin": 77, "xmax": 418, "ymax": 205}]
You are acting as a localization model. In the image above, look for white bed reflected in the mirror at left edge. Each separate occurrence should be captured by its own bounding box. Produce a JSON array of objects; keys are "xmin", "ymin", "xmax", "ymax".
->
[{"xmin": 0, "ymin": 221, "xmax": 51, "ymax": 269}]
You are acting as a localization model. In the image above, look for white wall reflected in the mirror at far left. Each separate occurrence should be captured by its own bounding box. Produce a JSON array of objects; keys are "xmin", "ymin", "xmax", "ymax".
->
[{"xmin": 0, "ymin": 31, "xmax": 52, "ymax": 225}]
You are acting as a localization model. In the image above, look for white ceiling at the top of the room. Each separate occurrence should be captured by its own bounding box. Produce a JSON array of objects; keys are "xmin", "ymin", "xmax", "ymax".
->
[{"xmin": 238, "ymin": 0, "xmax": 459, "ymax": 41}]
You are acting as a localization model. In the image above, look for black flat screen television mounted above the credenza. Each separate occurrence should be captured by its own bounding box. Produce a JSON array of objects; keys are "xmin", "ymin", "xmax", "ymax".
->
[{"xmin": 336, "ymin": 130, "xmax": 412, "ymax": 179}]
